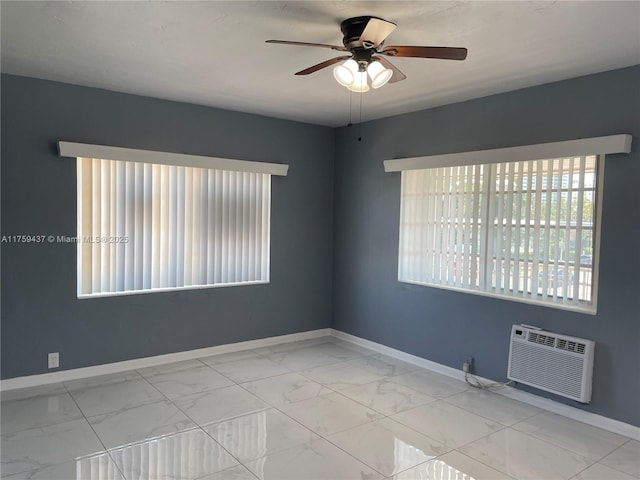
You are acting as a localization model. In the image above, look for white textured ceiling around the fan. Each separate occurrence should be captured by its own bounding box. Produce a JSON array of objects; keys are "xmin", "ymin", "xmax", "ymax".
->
[{"xmin": 0, "ymin": 0, "xmax": 640, "ymax": 126}]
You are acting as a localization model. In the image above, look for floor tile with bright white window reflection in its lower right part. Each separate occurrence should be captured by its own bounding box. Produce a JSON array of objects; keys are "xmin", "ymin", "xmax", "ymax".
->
[{"xmin": 327, "ymin": 418, "xmax": 450, "ymax": 476}]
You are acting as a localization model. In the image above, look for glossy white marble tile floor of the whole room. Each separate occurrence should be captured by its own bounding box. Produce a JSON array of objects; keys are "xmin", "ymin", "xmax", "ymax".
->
[{"xmin": 0, "ymin": 337, "xmax": 640, "ymax": 480}]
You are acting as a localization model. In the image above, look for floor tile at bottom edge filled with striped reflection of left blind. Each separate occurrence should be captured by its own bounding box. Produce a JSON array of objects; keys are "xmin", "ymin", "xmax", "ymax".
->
[{"xmin": 110, "ymin": 428, "xmax": 238, "ymax": 480}]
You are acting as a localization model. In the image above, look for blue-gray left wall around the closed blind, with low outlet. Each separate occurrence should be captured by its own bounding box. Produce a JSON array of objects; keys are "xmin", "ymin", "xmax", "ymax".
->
[{"xmin": 1, "ymin": 75, "xmax": 334, "ymax": 378}]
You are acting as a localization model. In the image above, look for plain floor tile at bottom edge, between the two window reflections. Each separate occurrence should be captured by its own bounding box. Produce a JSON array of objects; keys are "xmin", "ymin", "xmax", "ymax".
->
[{"xmin": 246, "ymin": 439, "xmax": 383, "ymax": 480}]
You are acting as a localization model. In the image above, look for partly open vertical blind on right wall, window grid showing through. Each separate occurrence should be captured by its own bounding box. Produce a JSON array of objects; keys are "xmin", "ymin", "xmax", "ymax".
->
[{"xmin": 398, "ymin": 155, "xmax": 598, "ymax": 305}]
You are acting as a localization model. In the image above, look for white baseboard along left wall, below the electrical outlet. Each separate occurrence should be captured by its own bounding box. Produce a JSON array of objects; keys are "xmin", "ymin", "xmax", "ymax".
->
[{"xmin": 0, "ymin": 328, "xmax": 330, "ymax": 391}]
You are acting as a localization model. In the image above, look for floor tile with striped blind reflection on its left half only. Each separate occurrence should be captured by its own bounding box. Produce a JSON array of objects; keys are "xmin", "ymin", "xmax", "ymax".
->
[{"xmin": 206, "ymin": 408, "xmax": 318, "ymax": 462}]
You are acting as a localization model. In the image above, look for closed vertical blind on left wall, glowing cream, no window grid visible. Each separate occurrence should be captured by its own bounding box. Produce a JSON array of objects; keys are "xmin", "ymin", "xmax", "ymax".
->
[{"xmin": 77, "ymin": 157, "xmax": 271, "ymax": 296}]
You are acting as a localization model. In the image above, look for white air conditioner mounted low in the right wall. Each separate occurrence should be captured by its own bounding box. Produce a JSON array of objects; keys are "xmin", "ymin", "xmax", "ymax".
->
[{"xmin": 507, "ymin": 325, "xmax": 595, "ymax": 403}]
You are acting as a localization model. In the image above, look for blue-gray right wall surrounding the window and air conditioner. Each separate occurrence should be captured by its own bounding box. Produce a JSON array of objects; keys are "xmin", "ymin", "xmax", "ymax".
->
[{"xmin": 332, "ymin": 66, "xmax": 640, "ymax": 425}]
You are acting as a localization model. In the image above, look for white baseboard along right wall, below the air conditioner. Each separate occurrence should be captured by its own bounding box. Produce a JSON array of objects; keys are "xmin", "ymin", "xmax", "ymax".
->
[{"xmin": 330, "ymin": 329, "xmax": 640, "ymax": 440}]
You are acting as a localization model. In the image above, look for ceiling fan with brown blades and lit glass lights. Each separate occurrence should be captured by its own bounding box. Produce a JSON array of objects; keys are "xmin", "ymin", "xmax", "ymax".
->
[{"xmin": 267, "ymin": 16, "xmax": 467, "ymax": 92}]
